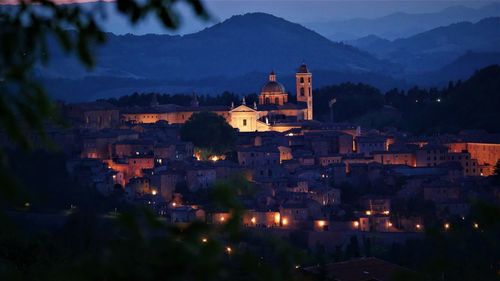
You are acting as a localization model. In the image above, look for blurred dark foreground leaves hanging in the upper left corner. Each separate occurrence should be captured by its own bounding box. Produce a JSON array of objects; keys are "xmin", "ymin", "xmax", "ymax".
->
[{"xmin": 0, "ymin": 0, "xmax": 209, "ymax": 197}]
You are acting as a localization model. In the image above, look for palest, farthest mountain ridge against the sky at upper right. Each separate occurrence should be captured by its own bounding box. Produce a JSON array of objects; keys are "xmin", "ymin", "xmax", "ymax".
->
[{"xmin": 305, "ymin": 2, "xmax": 500, "ymax": 41}]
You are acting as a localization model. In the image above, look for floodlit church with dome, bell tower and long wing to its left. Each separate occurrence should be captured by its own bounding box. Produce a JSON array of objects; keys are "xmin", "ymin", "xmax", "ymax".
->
[{"xmin": 122, "ymin": 64, "xmax": 313, "ymax": 132}]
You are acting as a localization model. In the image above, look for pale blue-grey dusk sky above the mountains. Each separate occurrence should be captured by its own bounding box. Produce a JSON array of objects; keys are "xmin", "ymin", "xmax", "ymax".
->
[{"xmin": 1, "ymin": 0, "xmax": 500, "ymax": 34}]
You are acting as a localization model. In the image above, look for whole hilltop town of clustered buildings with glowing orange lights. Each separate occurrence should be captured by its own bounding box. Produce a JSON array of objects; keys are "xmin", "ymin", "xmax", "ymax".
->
[{"xmin": 27, "ymin": 65, "xmax": 500, "ymax": 256}]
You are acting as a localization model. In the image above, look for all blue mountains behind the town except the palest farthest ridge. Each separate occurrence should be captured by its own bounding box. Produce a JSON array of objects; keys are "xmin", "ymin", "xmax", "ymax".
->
[{"xmin": 37, "ymin": 13, "xmax": 500, "ymax": 100}]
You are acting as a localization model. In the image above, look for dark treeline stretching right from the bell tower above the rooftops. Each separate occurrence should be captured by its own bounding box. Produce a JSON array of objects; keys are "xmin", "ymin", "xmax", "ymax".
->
[{"xmin": 314, "ymin": 65, "xmax": 500, "ymax": 134}]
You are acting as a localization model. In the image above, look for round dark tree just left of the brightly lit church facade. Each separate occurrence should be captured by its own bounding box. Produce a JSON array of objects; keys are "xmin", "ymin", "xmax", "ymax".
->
[{"xmin": 181, "ymin": 112, "xmax": 236, "ymax": 154}]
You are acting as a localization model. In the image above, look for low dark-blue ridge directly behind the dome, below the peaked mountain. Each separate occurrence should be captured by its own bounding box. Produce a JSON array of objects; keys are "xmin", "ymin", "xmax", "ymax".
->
[{"xmin": 43, "ymin": 70, "xmax": 407, "ymax": 102}]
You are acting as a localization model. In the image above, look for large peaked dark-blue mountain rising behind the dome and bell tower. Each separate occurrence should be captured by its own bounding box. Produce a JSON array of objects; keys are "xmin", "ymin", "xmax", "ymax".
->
[{"xmin": 39, "ymin": 13, "xmax": 394, "ymax": 80}]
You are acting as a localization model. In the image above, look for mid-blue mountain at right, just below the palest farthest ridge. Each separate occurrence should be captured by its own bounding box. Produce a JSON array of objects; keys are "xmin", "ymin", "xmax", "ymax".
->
[{"xmin": 352, "ymin": 17, "xmax": 500, "ymax": 73}]
